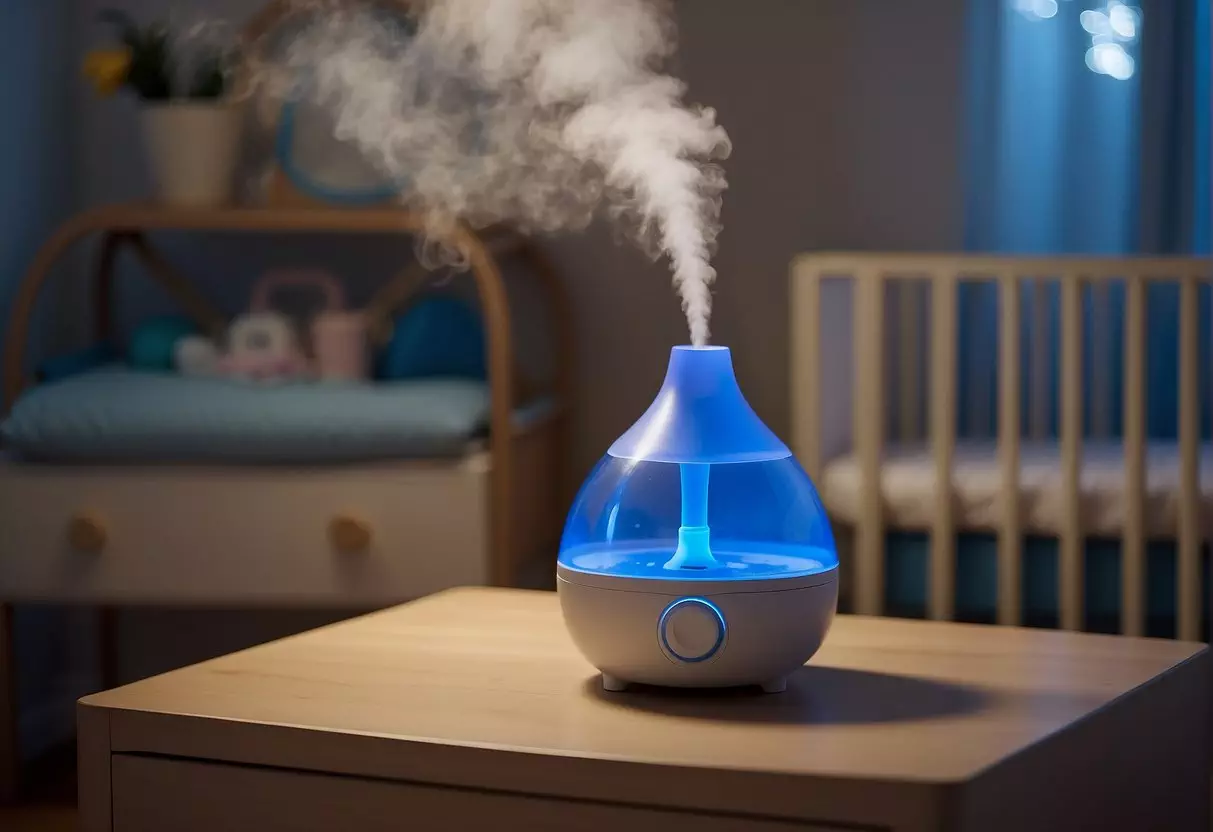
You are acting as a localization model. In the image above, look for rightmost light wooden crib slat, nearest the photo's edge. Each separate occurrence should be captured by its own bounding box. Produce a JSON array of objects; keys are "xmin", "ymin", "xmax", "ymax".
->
[{"xmin": 1177, "ymin": 275, "xmax": 1201, "ymax": 642}]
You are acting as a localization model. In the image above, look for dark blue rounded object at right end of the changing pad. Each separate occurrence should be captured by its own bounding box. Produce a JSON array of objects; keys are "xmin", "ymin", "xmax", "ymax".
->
[{"xmin": 377, "ymin": 295, "xmax": 486, "ymax": 380}]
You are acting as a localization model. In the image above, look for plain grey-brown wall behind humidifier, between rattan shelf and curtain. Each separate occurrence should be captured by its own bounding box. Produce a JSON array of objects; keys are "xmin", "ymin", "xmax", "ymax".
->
[{"xmin": 553, "ymin": 0, "xmax": 964, "ymax": 482}]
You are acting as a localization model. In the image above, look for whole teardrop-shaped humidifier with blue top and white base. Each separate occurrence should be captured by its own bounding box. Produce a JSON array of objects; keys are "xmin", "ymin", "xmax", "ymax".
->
[{"xmin": 557, "ymin": 347, "xmax": 838, "ymax": 693}]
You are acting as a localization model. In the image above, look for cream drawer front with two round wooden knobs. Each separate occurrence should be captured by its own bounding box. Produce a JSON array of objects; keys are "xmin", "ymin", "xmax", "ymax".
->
[{"xmin": 0, "ymin": 457, "xmax": 489, "ymax": 606}]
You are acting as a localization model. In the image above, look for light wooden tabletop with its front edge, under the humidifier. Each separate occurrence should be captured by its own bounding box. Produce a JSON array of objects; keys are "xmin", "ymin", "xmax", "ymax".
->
[{"xmin": 82, "ymin": 589, "xmax": 1207, "ymax": 783}]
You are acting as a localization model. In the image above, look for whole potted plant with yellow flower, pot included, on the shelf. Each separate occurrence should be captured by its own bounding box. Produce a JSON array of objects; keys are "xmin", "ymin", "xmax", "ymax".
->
[{"xmin": 84, "ymin": 10, "xmax": 243, "ymax": 207}]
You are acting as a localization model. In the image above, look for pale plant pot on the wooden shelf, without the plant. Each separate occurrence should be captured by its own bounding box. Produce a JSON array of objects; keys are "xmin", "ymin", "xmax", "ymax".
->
[{"xmin": 142, "ymin": 101, "xmax": 243, "ymax": 207}]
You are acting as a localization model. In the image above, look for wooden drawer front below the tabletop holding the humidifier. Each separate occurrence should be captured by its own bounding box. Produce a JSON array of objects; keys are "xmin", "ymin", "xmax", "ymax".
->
[{"xmin": 112, "ymin": 754, "xmax": 858, "ymax": 832}]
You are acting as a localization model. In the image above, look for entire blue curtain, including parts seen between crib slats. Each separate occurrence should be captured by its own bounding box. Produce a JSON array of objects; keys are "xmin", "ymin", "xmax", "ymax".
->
[{"xmin": 958, "ymin": 0, "xmax": 1213, "ymax": 438}]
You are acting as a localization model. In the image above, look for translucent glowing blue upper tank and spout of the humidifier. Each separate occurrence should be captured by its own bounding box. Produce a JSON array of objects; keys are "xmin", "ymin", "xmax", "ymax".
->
[{"xmin": 559, "ymin": 347, "xmax": 838, "ymax": 581}]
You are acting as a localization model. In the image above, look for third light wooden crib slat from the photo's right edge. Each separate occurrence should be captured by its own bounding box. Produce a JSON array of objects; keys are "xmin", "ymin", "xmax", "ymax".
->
[{"xmin": 1058, "ymin": 273, "xmax": 1084, "ymax": 629}]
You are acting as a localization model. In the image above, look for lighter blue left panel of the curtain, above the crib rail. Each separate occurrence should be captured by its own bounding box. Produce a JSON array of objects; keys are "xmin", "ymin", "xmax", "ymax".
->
[{"xmin": 966, "ymin": 0, "xmax": 1140, "ymax": 255}]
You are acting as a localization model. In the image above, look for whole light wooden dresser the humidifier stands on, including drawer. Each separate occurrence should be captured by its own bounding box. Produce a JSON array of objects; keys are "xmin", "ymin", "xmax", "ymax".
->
[{"xmin": 79, "ymin": 589, "xmax": 1213, "ymax": 832}]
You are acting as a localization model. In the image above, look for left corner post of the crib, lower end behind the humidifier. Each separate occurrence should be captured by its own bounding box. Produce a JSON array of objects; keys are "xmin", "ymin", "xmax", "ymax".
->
[{"xmin": 791, "ymin": 264, "xmax": 821, "ymax": 486}]
